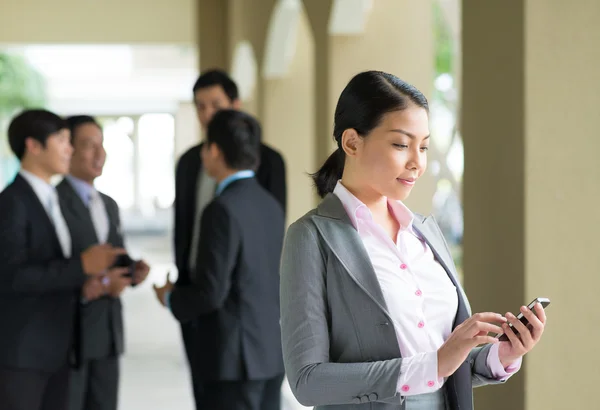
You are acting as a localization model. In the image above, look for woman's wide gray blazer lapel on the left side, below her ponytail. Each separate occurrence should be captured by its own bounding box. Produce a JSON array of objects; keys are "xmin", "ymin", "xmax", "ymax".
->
[{"xmin": 314, "ymin": 194, "xmax": 391, "ymax": 320}]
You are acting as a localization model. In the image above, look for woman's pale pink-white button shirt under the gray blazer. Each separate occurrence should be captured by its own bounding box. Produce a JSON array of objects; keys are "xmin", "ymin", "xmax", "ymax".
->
[{"xmin": 334, "ymin": 182, "xmax": 520, "ymax": 396}]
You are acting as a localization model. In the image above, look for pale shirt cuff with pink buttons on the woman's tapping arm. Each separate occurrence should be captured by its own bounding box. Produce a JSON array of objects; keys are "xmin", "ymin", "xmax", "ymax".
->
[{"xmin": 397, "ymin": 352, "xmax": 444, "ymax": 396}]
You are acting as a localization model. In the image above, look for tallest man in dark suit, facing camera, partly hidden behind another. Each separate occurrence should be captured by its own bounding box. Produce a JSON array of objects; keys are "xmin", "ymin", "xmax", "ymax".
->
[{"xmin": 174, "ymin": 70, "xmax": 286, "ymax": 406}]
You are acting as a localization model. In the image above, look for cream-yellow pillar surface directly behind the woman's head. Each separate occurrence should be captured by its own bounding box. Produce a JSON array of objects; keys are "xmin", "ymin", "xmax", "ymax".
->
[{"xmin": 329, "ymin": 0, "xmax": 435, "ymax": 214}]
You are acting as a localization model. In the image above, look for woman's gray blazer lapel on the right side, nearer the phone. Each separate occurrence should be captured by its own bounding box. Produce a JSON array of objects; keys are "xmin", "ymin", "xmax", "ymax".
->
[{"xmin": 413, "ymin": 215, "xmax": 471, "ymax": 324}]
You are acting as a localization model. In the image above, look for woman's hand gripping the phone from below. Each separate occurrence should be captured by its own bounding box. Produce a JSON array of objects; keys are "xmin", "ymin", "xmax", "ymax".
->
[{"xmin": 498, "ymin": 303, "xmax": 546, "ymax": 368}]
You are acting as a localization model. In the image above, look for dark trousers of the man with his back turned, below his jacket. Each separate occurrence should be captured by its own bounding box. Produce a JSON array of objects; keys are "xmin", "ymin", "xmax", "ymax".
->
[{"xmin": 196, "ymin": 374, "xmax": 284, "ymax": 410}]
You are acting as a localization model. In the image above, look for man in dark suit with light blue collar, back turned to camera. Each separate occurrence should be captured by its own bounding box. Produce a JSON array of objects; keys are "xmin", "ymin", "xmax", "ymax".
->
[{"xmin": 155, "ymin": 110, "xmax": 285, "ymax": 410}]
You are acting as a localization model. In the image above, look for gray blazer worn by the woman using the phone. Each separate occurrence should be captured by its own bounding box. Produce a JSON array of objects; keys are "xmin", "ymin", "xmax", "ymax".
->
[{"xmin": 281, "ymin": 194, "xmax": 500, "ymax": 410}]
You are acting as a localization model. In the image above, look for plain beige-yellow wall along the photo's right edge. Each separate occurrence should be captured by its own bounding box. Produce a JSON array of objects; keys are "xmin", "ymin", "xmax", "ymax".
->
[{"xmin": 525, "ymin": 0, "xmax": 600, "ymax": 410}]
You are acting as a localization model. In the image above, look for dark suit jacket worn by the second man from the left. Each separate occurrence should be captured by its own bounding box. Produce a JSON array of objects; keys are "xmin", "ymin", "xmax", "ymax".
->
[{"xmin": 56, "ymin": 179, "xmax": 124, "ymax": 360}]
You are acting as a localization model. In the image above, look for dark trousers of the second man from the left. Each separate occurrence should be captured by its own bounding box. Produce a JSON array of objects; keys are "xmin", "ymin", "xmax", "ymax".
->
[{"xmin": 69, "ymin": 357, "xmax": 119, "ymax": 410}]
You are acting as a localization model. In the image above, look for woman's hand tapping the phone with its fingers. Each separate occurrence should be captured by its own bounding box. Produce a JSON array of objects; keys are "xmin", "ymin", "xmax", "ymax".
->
[{"xmin": 437, "ymin": 312, "xmax": 506, "ymax": 378}]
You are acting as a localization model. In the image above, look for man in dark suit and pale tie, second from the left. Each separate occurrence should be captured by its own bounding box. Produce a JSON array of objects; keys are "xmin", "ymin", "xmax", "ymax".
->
[{"xmin": 57, "ymin": 115, "xmax": 149, "ymax": 410}]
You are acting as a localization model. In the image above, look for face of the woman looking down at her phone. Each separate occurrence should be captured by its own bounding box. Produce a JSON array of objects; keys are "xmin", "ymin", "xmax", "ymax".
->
[{"xmin": 346, "ymin": 106, "xmax": 429, "ymax": 200}]
